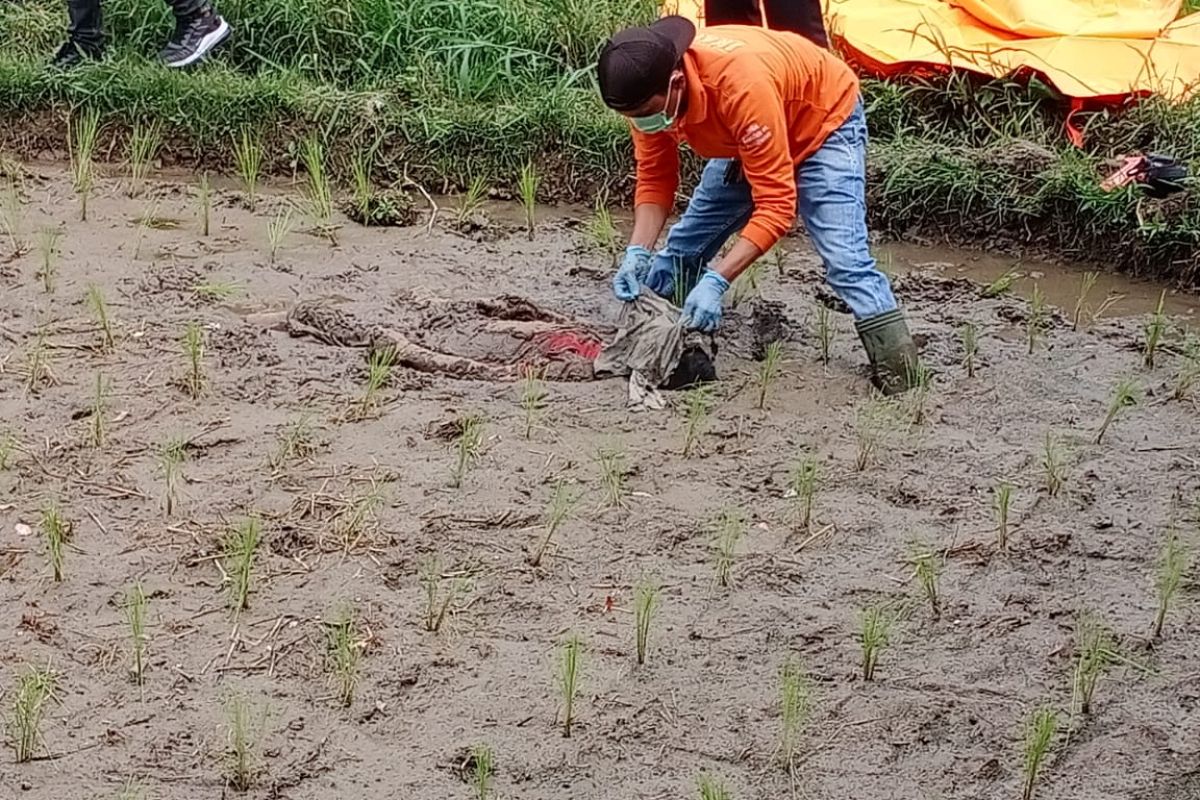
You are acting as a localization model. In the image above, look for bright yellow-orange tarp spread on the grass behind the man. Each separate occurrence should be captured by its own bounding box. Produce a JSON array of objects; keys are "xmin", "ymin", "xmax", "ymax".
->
[{"xmin": 664, "ymin": 0, "xmax": 1200, "ymax": 100}]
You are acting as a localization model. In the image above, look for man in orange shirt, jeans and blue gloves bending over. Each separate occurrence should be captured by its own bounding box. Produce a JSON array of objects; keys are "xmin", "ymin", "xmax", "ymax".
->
[{"xmin": 599, "ymin": 17, "xmax": 918, "ymax": 393}]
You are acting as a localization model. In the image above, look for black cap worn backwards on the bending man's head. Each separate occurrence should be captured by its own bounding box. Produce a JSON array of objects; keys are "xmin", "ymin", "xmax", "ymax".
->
[{"xmin": 596, "ymin": 17, "xmax": 696, "ymax": 112}]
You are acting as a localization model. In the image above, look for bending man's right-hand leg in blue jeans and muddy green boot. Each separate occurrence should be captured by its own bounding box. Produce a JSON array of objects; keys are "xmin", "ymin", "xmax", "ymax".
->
[{"xmin": 797, "ymin": 103, "xmax": 919, "ymax": 393}]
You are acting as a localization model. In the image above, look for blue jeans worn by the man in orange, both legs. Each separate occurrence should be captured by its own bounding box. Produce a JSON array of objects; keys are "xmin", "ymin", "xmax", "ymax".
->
[{"xmin": 648, "ymin": 103, "xmax": 896, "ymax": 319}]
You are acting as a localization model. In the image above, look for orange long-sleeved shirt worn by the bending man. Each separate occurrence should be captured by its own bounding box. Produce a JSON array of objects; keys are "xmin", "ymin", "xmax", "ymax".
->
[{"xmin": 634, "ymin": 25, "xmax": 858, "ymax": 252}]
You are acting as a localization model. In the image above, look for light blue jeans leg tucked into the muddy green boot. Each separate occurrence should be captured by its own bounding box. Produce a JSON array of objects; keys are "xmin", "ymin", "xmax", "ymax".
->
[{"xmin": 796, "ymin": 103, "xmax": 896, "ymax": 319}]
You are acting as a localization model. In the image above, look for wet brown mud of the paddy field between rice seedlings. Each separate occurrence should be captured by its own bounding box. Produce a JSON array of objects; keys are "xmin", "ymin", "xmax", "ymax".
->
[{"xmin": 0, "ymin": 168, "xmax": 1200, "ymax": 800}]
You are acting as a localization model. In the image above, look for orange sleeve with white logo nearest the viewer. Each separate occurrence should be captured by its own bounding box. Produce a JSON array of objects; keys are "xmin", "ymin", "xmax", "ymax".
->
[{"xmin": 719, "ymin": 71, "xmax": 796, "ymax": 253}]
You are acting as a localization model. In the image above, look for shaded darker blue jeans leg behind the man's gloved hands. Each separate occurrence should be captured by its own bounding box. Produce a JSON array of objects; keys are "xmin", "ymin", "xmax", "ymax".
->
[{"xmin": 646, "ymin": 158, "xmax": 754, "ymax": 302}]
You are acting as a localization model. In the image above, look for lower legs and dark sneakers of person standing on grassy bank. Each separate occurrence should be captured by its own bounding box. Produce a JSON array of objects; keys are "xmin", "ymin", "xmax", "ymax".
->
[{"xmin": 53, "ymin": 0, "xmax": 230, "ymax": 70}]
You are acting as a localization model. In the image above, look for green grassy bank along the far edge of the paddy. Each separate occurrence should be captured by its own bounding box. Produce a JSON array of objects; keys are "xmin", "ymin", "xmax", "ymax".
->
[{"xmin": 0, "ymin": 0, "xmax": 1200, "ymax": 284}]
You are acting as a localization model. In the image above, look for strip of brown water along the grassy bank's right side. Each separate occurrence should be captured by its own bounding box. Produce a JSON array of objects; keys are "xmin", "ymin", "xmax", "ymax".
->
[{"xmin": 875, "ymin": 242, "xmax": 1200, "ymax": 327}]
